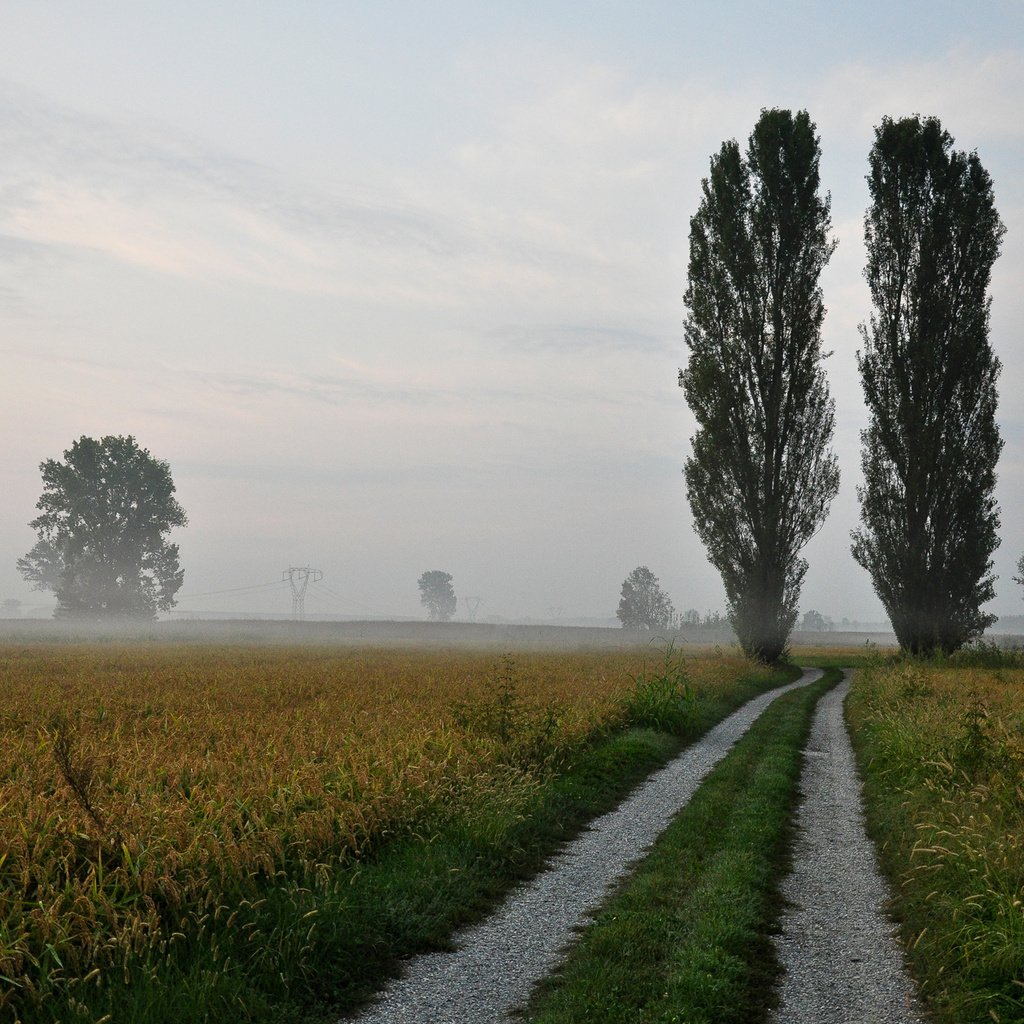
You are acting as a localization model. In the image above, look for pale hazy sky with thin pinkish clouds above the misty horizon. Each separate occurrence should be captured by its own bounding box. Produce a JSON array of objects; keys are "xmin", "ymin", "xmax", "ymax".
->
[{"xmin": 0, "ymin": 0, "xmax": 1024, "ymax": 618}]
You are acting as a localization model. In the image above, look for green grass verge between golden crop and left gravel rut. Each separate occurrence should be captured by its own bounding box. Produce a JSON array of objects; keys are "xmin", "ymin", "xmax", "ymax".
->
[{"xmin": 34, "ymin": 658, "xmax": 798, "ymax": 1024}]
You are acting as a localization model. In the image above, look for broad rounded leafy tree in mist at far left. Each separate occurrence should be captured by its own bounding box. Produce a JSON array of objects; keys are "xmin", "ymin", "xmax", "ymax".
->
[{"xmin": 17, "ymin": 436, "xmax": 187, "ymax": 618}]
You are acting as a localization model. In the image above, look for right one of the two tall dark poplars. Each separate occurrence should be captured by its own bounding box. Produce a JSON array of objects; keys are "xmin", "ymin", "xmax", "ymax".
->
[{"xmin": 853, "ymin": 117, "xmax": 1006, "ymax": 654}]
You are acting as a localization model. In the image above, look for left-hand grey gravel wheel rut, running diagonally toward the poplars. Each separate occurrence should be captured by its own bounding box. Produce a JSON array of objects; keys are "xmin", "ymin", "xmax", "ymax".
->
[{"xmin": 346, "ymin": 670, "xmax": 823, "ymax": 1024}]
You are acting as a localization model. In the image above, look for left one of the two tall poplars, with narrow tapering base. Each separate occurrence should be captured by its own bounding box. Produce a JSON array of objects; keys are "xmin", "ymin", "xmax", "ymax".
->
[{"xmin": 679, "ymin": 110, "xmax": 839, "ymax": 663}]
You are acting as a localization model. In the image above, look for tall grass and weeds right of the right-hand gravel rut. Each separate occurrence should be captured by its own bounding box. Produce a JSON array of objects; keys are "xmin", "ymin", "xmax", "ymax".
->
[{"xmin": 847, "ymin": 646, "xmax": 1024, "ymax": 1024}]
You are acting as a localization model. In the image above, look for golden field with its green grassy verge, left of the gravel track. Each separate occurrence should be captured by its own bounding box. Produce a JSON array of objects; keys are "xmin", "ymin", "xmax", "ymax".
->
[{"xmin": 0, "ymin": 642, "xmax": 780, "ymax": 1022}]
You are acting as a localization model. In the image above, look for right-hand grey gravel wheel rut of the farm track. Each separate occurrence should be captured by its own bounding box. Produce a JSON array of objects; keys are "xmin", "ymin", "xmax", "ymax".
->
[{"xmin": 774, "ymin": 675, "xmax": 924, "ymax": 1024}]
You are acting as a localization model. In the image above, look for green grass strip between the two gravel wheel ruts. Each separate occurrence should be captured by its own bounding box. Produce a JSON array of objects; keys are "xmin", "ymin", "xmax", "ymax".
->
[{"xmin": 524, "ymin": 670, "xmax": 840, "ymax": 1024}]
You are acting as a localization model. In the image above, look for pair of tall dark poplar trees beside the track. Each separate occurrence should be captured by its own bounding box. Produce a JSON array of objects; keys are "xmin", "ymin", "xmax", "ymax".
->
[{"xmin": 679, "ymin": 110, "xmax": 1005, "ymax": 663}]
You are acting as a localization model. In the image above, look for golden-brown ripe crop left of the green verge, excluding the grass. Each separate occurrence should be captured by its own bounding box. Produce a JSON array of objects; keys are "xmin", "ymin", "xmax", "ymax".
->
[{"xmin": 0, "ymin": 644, "xmax": 770, "ymax": 1019}]
